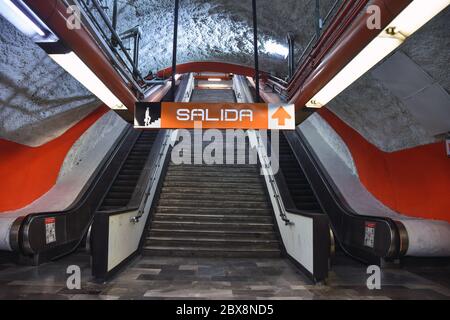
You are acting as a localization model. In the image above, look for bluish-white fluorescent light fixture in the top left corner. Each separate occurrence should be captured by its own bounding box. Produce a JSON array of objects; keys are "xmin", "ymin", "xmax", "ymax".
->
[{"xmin": 0, "ymin": 0, "xmax": 58, "ymax": 42}]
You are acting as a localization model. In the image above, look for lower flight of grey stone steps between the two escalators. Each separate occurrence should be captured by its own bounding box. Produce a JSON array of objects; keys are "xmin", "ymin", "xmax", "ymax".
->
[{"xmin": 144, "ymin": 132, "xmax": 280, "ymax": 258}]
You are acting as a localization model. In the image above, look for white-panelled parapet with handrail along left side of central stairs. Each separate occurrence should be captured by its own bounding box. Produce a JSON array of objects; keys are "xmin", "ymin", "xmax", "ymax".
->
[{"xmin": 90, "ymin": 73, "xmax": 194, "ymax": 281}]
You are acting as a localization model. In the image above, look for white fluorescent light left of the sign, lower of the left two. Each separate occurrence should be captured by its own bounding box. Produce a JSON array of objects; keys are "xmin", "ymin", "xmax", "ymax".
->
[{"xmin": 49, "ymin": 52, "xmax": 127, "ymax": 110}]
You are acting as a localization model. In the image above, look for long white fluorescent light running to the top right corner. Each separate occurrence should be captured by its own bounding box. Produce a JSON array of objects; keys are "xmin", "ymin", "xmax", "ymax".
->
[{"xmin": 306, "ymin": 0, "xmax": 450, "ymax": 108}]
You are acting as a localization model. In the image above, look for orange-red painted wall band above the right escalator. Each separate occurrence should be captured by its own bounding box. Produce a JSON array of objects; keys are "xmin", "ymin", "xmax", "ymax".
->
[{"xmin": 319, "ymin": 108, "xmax": 450, "ymax": 222}]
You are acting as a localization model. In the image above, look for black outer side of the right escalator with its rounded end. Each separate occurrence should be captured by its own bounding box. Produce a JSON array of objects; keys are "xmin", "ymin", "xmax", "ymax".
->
[{"xmin": 285, "ymin": 132, "xmax": 398, "ymax": 264}]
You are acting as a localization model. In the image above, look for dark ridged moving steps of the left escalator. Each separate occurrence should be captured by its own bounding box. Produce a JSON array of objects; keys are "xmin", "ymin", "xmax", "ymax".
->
[{"xmin": 98, "ymin": 131, "xmax": 158, "ymax": 211}]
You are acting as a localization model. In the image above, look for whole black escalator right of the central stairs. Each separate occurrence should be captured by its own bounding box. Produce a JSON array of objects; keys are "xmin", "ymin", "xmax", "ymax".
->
[{"xmin": 279, "ymin": 131, "xmax": 403, "ymax": 264}]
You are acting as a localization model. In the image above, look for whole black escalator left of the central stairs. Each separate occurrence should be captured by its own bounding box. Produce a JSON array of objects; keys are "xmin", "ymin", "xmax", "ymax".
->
[{"xmin": 11, "ymin": 126, "xmax": 162, "ymax": 265}]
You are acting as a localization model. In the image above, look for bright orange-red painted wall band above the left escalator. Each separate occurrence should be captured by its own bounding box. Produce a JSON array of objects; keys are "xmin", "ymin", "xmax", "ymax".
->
[{"xmin": 0, "ymin": 106, "xmax": 109, "ymax": 213}]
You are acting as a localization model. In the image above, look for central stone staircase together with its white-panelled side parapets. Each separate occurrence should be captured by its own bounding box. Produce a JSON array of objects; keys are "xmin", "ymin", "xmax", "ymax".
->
[{"xmin": 90, "ymin": 78, "xmax": 330, "ymax": 281}]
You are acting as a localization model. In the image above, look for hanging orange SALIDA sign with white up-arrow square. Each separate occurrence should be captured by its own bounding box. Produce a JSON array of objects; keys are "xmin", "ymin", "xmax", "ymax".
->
[{"xmin": 134, "ymin": 102, "xmax": 295, "ymax": 130}]
